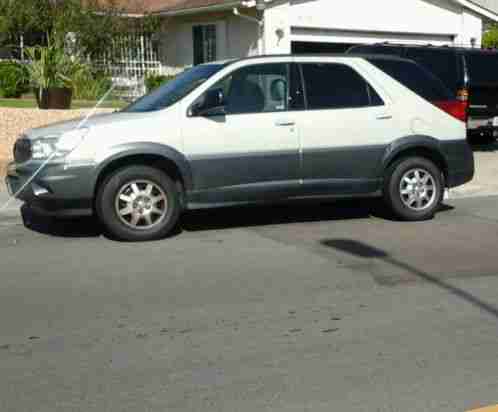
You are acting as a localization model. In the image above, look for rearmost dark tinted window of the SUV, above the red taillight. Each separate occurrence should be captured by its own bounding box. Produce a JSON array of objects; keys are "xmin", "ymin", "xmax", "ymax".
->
[{"xmin": 368, "ymin": 59, "xmax": 454, "ymax": 102}]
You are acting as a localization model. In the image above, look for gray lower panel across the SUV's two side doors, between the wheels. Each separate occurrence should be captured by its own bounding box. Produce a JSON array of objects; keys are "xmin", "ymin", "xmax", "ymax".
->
[{"xmin": 187, "ymin": 145, "xmax": 386, "ymax": 209}]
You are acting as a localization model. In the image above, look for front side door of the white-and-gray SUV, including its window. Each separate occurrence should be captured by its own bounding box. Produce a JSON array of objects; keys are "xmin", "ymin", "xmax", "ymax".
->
[{"xmin": 182, "ymin": 63, "xmax": 300, "ymax": 204}]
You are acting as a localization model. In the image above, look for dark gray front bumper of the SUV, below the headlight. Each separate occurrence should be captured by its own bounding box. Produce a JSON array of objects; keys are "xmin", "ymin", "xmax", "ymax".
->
[{"xmin": 5, "ymin": 161, "xmax": 95, "ymax": 217}]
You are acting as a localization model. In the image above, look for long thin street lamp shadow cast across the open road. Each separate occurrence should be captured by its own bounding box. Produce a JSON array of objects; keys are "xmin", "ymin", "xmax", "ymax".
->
[{"xmin": 320, "ymin": 239, "xmax": 498, "ymax": 318}]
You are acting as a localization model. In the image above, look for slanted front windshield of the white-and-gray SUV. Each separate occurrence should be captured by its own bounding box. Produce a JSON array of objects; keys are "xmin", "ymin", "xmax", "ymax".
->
[{"xmin": 123, "ymin": 64, "xmax": 225, "ymax": 113}]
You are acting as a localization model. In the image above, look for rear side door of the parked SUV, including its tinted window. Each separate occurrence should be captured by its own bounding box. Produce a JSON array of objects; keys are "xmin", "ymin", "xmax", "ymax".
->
[{"xmin": 296, "ymin": 61, "xmax": 395, "ymax": 195}]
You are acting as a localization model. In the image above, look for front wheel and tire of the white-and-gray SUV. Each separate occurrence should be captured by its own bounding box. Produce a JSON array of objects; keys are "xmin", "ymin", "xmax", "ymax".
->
[{"xmin": 95, "ymin": 166, "xmax": 181, "ymax": 241}]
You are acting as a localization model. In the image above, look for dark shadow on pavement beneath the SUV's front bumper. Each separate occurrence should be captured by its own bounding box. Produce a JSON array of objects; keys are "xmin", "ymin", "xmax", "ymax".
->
[{"xmin": 21, "ymin": 205, "xmax": 103, "ymax": 238}]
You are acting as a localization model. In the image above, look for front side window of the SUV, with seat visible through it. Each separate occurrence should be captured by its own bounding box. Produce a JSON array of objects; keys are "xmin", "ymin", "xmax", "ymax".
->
[{"xmin": 198, "ymin": 63, "xmax": 289, "ymax": 114}]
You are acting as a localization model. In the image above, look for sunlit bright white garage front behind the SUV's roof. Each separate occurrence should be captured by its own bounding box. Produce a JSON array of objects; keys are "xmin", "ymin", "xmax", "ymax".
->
[{"xmin": 265, "ymin": 0, "xmax": 482, "ymax": 53}]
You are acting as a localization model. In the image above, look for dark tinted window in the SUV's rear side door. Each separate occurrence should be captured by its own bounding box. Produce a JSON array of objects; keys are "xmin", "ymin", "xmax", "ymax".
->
[{"xmin": 301, "ymin": 63, "xmax": 383, "ymax": 110}]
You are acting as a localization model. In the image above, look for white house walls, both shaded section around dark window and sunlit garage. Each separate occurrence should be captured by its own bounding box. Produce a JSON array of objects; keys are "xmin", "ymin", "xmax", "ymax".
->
[{"xmin": 161, "ymin": 0, "xmax": 482, "ymax": 67}]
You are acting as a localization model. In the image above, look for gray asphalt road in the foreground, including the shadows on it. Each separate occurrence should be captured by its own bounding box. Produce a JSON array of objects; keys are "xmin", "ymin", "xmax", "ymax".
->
[{"xmin": 0, "ymin": 193, "xmax": 498, "ymax": 412}]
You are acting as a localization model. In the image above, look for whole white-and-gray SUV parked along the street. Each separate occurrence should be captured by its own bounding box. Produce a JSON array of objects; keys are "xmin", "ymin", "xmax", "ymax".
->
[{"xmin": 7, "ymin": 55, "xmax": 474, "ymax": 240}]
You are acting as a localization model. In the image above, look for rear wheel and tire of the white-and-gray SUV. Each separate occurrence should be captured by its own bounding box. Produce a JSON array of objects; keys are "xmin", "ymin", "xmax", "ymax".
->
[{"xmin": 383, "ymin": 157, "xmax": 445, "ymax": 221}]
